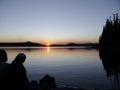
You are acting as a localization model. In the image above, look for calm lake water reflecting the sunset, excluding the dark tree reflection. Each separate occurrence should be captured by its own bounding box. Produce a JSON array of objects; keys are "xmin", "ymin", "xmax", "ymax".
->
[{"xmin": 0, "ymin": 47, "xmax": 119, "ymax": 88}]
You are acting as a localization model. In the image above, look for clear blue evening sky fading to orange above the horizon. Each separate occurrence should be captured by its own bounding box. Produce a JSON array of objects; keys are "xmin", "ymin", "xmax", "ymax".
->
[{"xmin": 0, "ymin": 0, "xmax": 120, "ymax": 44}]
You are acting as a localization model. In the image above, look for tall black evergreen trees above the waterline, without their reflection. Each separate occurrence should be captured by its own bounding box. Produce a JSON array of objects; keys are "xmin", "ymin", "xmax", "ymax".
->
[{"xmin": 99, "ymin": 13, "xmax": 120, "ymax": 48}]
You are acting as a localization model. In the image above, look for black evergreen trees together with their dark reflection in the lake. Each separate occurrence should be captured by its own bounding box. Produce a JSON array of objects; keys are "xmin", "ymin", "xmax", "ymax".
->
[{"xmin": 99, "ymin": 13, "xmax": 120, "ymax": 87}]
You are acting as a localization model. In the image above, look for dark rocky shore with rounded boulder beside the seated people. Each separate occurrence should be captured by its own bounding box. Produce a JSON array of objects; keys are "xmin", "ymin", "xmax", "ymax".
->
[{"xmin": 29, "ymin": 75, "xmax": 120, "ymax": 90}]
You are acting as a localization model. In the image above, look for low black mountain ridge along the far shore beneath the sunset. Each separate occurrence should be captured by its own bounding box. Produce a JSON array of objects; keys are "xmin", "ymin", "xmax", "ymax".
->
[{"xmin": 0, "ymin": 41, "xmax": 98, "ymax": 48}]
